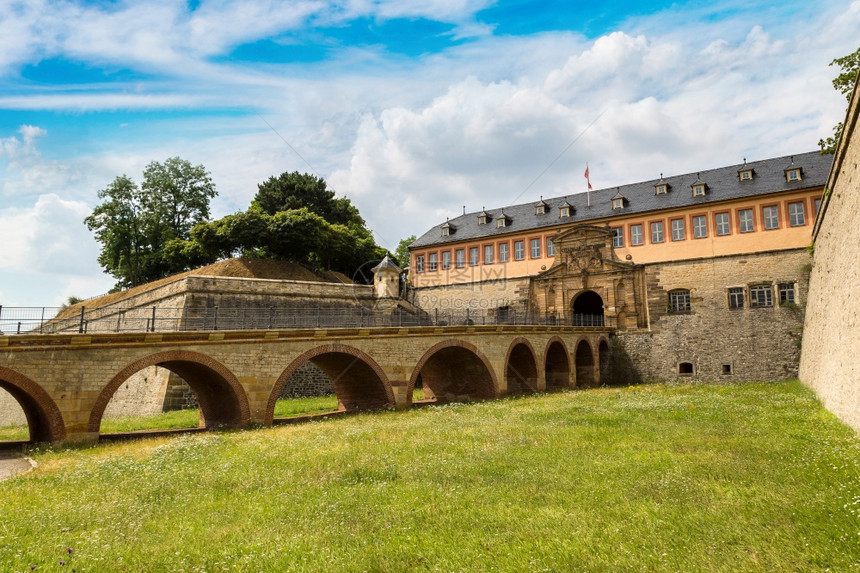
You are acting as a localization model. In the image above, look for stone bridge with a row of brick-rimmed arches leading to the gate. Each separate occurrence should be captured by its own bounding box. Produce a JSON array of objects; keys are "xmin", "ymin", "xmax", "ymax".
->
[{"xmin": 0, "ymin": 325, "xmax": 609, "ymax": 442}]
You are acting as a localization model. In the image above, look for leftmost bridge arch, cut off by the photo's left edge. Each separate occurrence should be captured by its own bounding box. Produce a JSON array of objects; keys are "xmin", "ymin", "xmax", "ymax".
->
[{"xmin": 0, "ymin": 366, "xmax": 66, "ymax": 443}]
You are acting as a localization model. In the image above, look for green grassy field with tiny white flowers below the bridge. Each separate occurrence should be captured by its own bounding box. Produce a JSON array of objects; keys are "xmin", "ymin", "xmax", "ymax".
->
[{"xmin": 0, "ymin": 382, "xmax": 860, "ymax": 572}]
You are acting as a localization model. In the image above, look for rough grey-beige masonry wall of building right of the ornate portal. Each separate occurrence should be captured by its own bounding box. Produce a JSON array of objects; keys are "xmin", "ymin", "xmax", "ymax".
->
[{"xmin": 611, "ymin": 250, "xmax": 811, "ymax": 383}]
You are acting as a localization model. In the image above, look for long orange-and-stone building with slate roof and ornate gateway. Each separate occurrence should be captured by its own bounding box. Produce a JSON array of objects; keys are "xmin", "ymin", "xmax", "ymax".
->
[{"xmin": 409, "ymin": 152, "xmax": 832, "ymax": 382}]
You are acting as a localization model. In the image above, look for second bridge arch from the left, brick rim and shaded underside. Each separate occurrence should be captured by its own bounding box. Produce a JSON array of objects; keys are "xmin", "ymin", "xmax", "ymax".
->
[{"xmin": 87, "ymin": 350, "xmax": 251, "ymax": 433}]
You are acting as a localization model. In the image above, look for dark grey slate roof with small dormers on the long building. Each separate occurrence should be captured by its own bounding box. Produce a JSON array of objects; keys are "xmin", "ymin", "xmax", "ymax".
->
[{"xmin": 409, "ymin": 151, "xmax": 833, "ymax": 249}]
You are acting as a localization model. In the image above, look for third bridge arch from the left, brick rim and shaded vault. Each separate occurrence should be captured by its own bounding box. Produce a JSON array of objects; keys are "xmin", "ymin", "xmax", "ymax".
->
[{"xmin": 266, "ymin": 344, "xmax": 394, "ymax": 425}]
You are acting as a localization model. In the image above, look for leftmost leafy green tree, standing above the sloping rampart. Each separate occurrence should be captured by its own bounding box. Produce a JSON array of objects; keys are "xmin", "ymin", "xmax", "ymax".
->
[{"xmin": 84, "ymin": 157, "xmax": 216, "ymax": 288}]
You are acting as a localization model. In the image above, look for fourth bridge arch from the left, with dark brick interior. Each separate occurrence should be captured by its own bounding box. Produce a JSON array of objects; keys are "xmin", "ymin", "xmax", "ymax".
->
[{"xmin": 406, "ymin": 339, "xmax": 499, "ymax": 404}]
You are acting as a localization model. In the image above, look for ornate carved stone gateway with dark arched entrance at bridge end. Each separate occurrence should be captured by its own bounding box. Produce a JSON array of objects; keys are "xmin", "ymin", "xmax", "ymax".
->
[{"xmin": 532, "ymin": 225, "xmax": 647, "ymax": 330}]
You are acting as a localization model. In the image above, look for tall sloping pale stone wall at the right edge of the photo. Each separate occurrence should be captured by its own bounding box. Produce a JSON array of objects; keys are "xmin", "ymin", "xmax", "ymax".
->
[{"xmin": 800, "ymin": 79, "xmax": 860, "ymax": 431}]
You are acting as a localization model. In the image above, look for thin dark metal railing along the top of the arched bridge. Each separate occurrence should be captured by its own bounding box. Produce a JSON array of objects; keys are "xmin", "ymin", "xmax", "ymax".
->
[{"xmin": 0, "ymin": 305, "xmax": 612, "ymax": 335}]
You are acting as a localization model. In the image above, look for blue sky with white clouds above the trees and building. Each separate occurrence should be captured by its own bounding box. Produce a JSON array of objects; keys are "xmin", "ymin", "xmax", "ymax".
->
[{"xmin": 0, "ymin": 0, "xmax": 860, "ymax": 307}]
